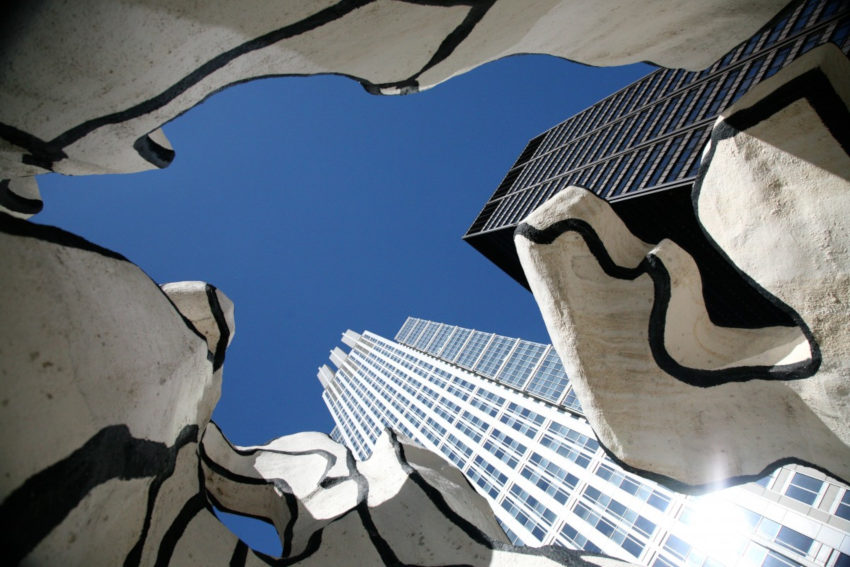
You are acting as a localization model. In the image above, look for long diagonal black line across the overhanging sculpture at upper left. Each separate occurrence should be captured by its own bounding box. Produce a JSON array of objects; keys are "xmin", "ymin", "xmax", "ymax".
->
[{"xmin": 38, "ymin": 0, "xmax": 374, "ymax": 160}]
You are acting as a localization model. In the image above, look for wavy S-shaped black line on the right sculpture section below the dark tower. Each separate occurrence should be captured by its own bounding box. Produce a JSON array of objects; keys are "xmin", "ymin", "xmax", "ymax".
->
[{"xmin": 514, "ymin": 215, "xmax": 821, "ymax": 388}]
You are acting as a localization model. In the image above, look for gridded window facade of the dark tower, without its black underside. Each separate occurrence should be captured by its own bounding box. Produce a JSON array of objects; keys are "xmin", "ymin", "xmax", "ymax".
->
[{"xmin": 470, "ymin": 0, "xmax": 850, "ymax": 232}]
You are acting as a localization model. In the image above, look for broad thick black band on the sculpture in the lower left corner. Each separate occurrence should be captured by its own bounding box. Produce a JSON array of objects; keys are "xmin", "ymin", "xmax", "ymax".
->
[{"xmin": 0, "ymin": 425, "xmax": 197, "ymax": 565}]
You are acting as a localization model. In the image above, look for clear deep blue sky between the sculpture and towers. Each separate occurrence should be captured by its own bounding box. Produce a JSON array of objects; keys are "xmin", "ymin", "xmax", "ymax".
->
[{"xmin": 33, "ymin": 56, "xmax": 652, "ymax": 553}]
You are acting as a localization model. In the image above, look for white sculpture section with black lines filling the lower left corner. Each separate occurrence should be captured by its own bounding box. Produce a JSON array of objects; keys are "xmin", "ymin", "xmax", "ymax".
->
[{"xmin": 0, "ymin": 209, "xmax": 644, "ymax": 566}]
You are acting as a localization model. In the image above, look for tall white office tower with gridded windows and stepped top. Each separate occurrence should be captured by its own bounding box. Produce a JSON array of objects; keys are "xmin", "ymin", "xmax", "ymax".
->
[{"xmin": 318, "ymin": 318, "xmax": 850, "ymax": 567}]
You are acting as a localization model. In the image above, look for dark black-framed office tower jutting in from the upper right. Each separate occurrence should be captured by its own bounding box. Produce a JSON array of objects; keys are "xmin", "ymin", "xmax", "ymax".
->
[{"xmin": 464, "ymin": 0, "xmax": 850, "ymax": 292}]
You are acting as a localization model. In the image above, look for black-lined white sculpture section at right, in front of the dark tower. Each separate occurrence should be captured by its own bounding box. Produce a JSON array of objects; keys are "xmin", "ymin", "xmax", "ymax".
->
[{"xmin": 515, "ymin": 45, "xmax": 850, "ymax": 487}]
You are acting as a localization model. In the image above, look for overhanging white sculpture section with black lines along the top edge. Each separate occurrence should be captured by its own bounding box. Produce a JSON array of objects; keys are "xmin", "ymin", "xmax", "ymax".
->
[{"xmin": 0, "ymin": 0, "xmax": 787, "ymax": 215}]
